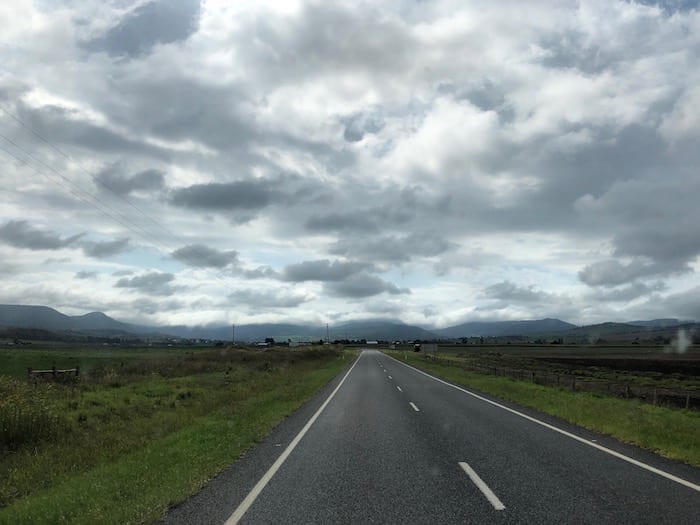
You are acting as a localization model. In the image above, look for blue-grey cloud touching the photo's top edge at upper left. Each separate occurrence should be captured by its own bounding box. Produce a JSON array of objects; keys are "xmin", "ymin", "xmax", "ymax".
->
[{"xmin": 82, "ymin": 0, "xmax": 200, "ymax": 57}]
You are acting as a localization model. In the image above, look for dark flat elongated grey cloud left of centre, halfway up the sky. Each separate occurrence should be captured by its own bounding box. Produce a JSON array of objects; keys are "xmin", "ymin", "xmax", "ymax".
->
[{"xmin": 170, "ymin": 181, "xmax": 276, "ymax": 211}]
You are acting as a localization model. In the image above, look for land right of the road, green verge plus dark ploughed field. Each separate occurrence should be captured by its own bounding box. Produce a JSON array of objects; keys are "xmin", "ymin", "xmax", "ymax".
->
[{"xmin": 388, "ymin": 345, "xmax": 700, "ymax": 466}]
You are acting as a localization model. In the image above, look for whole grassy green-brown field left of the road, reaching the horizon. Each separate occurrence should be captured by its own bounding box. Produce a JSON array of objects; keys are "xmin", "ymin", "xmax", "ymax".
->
[{"xmin": 0, "ymin": 345, "xmax": 349, "ymax": 523}]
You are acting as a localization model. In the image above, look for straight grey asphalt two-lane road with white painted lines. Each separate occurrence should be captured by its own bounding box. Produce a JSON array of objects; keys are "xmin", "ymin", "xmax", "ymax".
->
[{"xmin": 164, "ymin": 350, "xmax": 700, "ymax": 524}]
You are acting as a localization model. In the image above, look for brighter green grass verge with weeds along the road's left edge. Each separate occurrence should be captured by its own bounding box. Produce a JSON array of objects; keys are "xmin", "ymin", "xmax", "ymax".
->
[{"xmin": 0, "ymin": 346, "xmax": 350, "ymax": 524}]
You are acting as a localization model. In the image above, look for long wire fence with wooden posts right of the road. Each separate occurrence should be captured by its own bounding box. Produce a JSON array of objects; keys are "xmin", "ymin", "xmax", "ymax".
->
[{"xmin": 426, "ymin": 356, "xmax": 700, "ymax": 410}]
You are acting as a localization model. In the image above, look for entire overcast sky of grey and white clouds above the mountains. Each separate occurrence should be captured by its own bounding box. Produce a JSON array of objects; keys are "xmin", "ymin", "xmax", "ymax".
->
[{"xmin": 0, "ymin": 0, "xmax": 700, "ymax": 328}]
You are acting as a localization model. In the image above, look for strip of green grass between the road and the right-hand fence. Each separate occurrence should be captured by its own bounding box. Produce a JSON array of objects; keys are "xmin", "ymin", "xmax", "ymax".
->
[{"xmin": 388, "ymin": 352, "xmax": 700, "ymax": 467}]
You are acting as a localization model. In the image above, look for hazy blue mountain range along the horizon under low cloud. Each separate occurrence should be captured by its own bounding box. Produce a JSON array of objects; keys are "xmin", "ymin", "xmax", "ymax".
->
[{"xmin": 0, "ymin": 305, "xmax": 693, "ymax": 342}]
